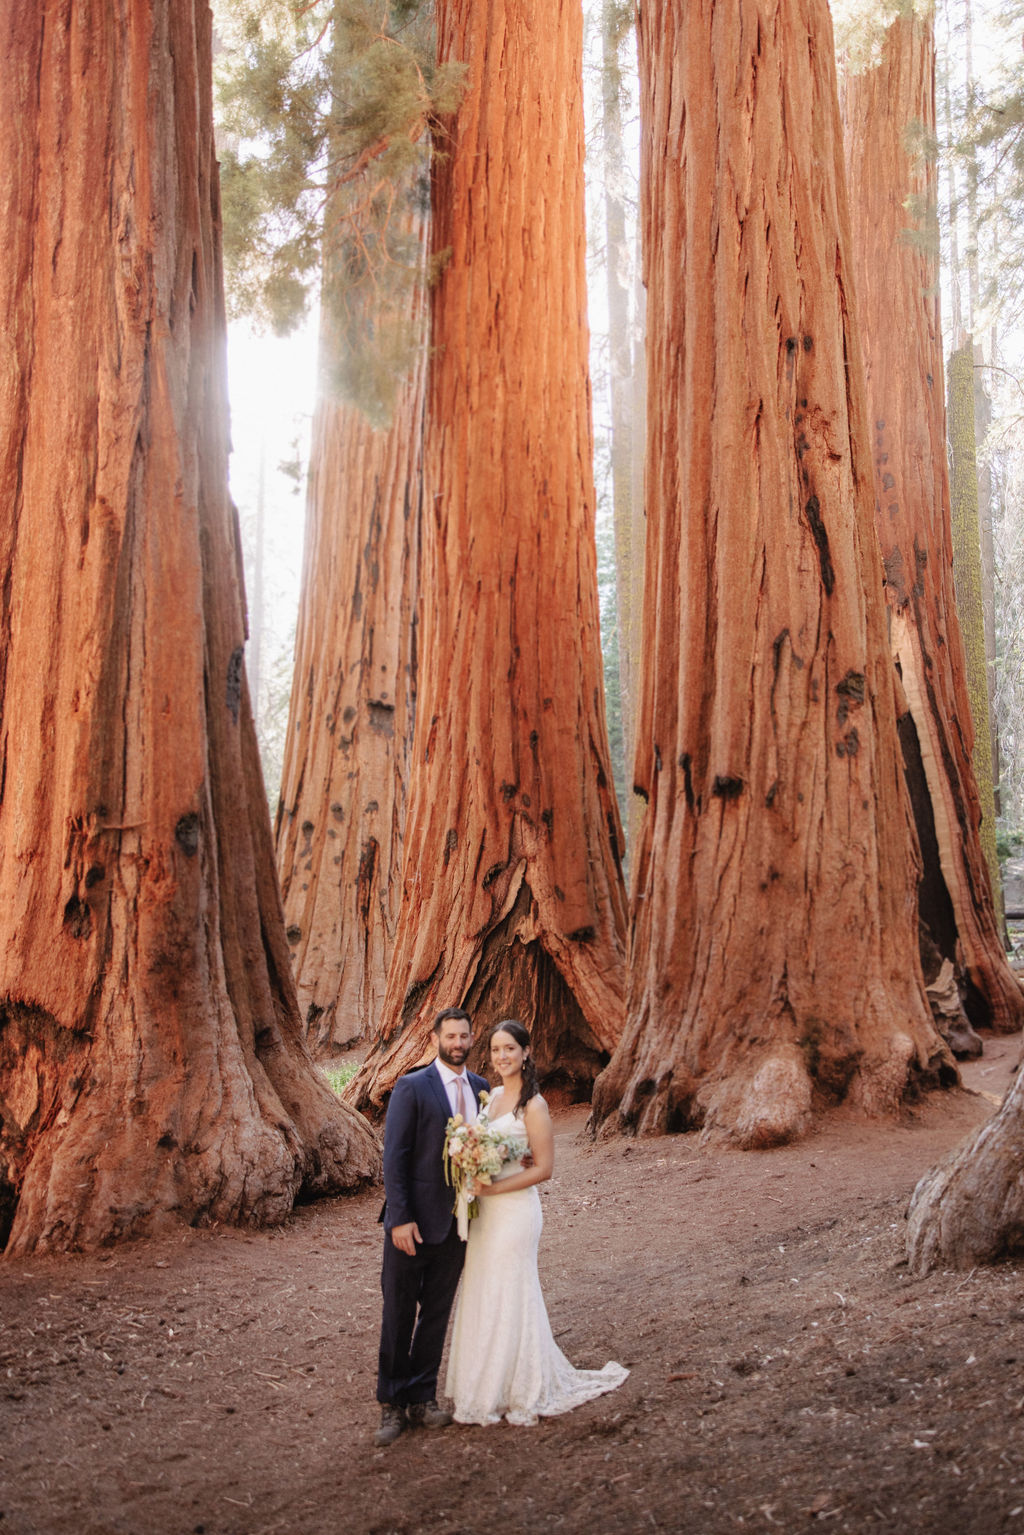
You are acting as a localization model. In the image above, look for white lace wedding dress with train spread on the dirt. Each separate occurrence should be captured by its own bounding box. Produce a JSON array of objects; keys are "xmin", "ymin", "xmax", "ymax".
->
[{"xmin": 447, "ymin": 1113, "xmax": 629, "ymax": 1424}]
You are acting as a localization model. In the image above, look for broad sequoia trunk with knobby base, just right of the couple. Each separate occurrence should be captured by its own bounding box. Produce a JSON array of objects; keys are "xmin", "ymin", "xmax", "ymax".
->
[{"xmin": 593, "ymin": 0, "xmax": 949, "ymax": 1147}]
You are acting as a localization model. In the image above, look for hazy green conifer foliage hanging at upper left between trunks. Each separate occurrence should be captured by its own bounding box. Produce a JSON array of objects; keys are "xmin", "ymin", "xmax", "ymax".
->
[{"xmin": 218, "ymin": 0, "xmax": 462, "ymax": 424}]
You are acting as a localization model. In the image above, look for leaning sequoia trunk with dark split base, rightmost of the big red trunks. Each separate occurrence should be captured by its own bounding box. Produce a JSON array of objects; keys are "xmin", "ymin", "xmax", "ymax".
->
[{"xmin": 844, "ymin": 15, "xmax": 1024, "ymax": 1030}]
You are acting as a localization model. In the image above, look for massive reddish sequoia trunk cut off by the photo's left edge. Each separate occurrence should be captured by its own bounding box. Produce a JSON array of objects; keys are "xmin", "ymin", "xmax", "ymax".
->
[{"xmin": 0, "ymin": 0, "xmax": 378, "ymax": 1253}]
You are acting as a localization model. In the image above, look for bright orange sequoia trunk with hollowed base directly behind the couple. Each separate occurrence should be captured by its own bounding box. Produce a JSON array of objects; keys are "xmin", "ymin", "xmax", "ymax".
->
[{"xmin": 352, "ymin": 0, "xmax": 625, "ymax": 1105}]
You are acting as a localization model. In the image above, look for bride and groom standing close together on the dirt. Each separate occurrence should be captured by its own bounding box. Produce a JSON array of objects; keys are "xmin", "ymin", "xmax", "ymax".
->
[{"xmin": 375, "ymin": 1007, "xmax": 629, "ymax": 1444}]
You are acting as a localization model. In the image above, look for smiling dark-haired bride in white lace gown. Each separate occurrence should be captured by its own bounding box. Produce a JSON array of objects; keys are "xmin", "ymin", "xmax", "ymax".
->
[{"xmin": 447, "ymin": 1018, "xmax": 629, "ymax": 1424}]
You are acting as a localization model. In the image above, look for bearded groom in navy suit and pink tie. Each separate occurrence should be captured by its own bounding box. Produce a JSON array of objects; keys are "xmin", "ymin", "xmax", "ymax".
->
[{"xmin": 373, "ymin": 1007, "xmax": 487, "ymax": 1444}]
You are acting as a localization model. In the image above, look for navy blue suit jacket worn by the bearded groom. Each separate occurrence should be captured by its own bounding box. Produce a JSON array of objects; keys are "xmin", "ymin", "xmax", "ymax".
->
[{"xmin": 381, "ymin": 1064, "xmax": 487, "ymax": 1242}]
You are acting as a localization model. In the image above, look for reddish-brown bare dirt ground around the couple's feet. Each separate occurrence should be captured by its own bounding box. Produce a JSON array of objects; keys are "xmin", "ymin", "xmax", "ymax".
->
[{"xmin": 0, "ymin": 1038, "xmax": 1024, "ymax": 1535}]
